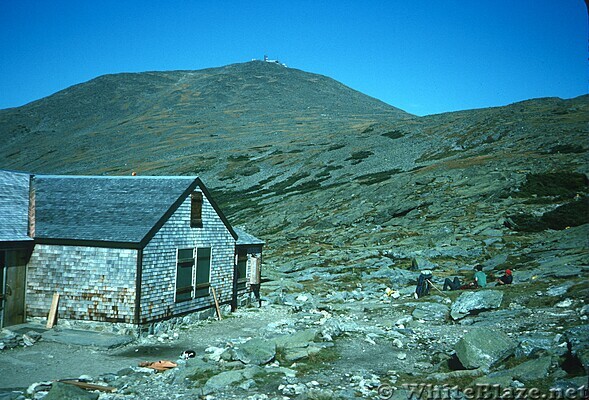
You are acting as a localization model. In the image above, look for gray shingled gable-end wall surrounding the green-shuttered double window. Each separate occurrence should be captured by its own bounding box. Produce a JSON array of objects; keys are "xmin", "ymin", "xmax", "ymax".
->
[{"xmin": 141, "ymin": 189, "xmax": 235, "ymax": 323}]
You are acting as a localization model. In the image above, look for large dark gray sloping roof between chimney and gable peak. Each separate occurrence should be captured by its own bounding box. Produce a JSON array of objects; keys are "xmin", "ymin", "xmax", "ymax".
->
[{"xmin": 33, "ymin": 175, "xmax": 200, "ymax": 243}]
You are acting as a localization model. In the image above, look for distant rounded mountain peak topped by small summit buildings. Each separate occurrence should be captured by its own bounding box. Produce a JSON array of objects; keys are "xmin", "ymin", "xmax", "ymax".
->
[{"xmin": 0, "ymin": 61, "xmax": 411, "ymax": 174}]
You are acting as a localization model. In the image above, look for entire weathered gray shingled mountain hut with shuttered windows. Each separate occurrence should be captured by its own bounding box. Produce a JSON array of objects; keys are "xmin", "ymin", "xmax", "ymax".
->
[{"xmin": 0, "ymin": 171, "xmax": 263, "ymax": 326}]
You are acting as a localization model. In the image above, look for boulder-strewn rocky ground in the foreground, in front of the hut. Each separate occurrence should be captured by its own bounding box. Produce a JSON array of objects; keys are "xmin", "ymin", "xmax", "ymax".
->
[{"xmin": 0, "ymin": 225, "xmax": 589, "ymax": 399}]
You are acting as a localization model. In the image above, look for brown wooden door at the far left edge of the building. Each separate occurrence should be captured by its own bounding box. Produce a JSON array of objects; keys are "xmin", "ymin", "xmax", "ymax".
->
[{"xmin": 2, "ymin": 250, "xmax": 27, "ymax": 326}]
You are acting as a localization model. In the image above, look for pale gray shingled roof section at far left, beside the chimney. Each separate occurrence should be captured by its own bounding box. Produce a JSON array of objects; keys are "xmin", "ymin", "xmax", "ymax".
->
[{"xmin": 0, "ymin": 170, "xmax": 32, "ymax": 242}]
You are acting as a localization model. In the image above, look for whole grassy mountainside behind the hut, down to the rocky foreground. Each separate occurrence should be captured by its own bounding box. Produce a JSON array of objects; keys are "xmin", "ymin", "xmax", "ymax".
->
[{"xmin": 0, "ymin": 62, "xmax": 589, "ymax": 267}]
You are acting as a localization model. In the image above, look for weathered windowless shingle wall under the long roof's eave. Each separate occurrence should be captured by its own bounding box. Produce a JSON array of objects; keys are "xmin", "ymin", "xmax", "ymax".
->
[{"xmin": 26, "ymin": 244, "xmax": 137, "ymax": 323}]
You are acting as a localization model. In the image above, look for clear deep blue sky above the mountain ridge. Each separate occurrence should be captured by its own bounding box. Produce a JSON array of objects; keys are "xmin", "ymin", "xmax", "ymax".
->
[{"xmin": 0, "ymin": 0, "xmax": 588, "ymax": 115}]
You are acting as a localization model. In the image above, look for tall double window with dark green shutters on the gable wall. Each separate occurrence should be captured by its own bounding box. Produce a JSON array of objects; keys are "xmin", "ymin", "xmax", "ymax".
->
[{"xmin": 176, "ymin": 247, "xmax": 211, "ymax": 303}]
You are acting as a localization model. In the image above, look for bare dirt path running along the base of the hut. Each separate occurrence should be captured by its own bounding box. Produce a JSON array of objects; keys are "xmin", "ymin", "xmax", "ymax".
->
[{"xmin": 0, "ymin": 307, "xmax": 288, "ymax": 392}]
